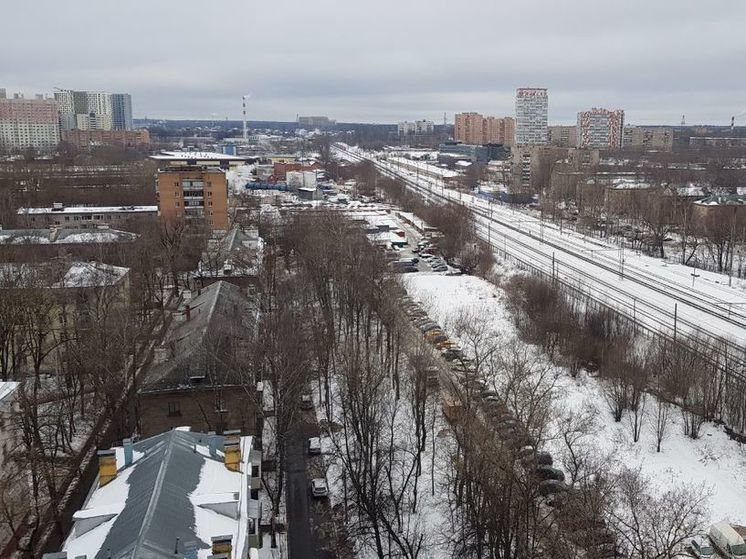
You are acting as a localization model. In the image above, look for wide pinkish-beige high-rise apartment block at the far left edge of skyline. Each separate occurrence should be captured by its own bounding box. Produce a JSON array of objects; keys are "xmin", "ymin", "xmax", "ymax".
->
[{"xmin": 0, "ymin": 89, "xmax": 60, "ymax": 151}]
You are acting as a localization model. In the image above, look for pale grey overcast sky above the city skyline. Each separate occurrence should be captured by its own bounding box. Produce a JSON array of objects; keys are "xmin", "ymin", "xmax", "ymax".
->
[{"xmin": 0, "ymin": 0, "xmax": 746, "ymax": 125}]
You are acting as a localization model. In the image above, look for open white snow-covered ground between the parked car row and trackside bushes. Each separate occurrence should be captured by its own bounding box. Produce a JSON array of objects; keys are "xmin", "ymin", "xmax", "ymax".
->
[{"xmin": 404, "ymin": 273, "xmax": 746, "ymax": 525}]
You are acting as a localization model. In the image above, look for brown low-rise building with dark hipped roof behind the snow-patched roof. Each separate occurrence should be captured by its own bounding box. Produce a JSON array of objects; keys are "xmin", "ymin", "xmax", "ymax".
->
[{"xmin": 136, "ymin": 280, "xmax": 256, "ymax": 436}]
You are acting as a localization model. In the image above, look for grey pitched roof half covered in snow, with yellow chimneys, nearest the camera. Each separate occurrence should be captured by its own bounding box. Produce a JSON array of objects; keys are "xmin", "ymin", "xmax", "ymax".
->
[{"xmin": 63, "ymin": 430, "xmax": 259, "ymax": 559}]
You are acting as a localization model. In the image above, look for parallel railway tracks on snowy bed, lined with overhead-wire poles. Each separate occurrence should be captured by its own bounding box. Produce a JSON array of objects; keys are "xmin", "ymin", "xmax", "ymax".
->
[{"xmin": 338, "ymin": 144, "xmax": 746, "ymax": 381}]
